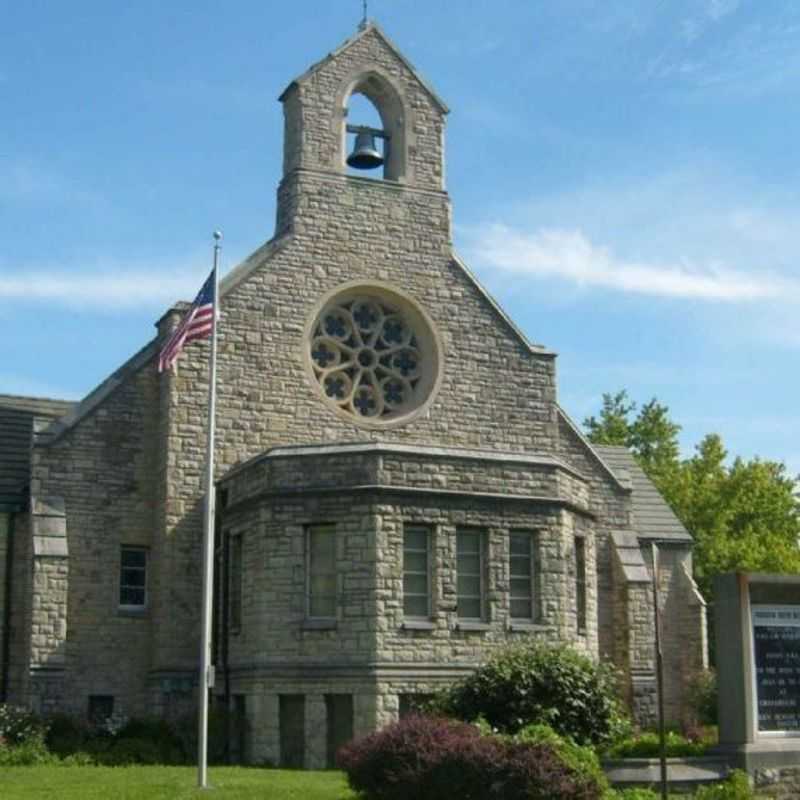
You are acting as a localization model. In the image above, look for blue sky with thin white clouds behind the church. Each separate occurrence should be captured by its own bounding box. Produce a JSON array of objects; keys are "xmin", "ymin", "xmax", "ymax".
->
[{"xmin": 0, "ymin": 0, "xmax": 800, "ymax": 472}]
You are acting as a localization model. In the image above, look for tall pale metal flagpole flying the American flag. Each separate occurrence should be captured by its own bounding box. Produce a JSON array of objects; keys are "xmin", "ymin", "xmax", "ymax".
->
[{"xmin": 197, "ymin": 231, "xmax": 222, "ymax": 789}]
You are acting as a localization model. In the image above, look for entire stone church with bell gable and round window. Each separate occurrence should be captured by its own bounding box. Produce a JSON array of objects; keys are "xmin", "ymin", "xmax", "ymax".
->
[{"xmin": 0, "ymin": 23, "xmax": 705, "ymax": 767}]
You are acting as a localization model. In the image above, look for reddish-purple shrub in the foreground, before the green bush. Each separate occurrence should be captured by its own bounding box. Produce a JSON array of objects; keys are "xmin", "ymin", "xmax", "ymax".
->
[{"xmin": 337, "ymin": 716, "xmax": 603, "ymax": 800}]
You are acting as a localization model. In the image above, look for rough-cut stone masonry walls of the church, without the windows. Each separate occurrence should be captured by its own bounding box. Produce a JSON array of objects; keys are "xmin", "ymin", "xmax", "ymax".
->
[{"xmin": 4, "ymin": 20, "xmax": 708, "ymax": 766}]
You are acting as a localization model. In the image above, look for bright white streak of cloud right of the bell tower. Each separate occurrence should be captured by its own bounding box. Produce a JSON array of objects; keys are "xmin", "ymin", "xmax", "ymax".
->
[{"xmin": 469, "ymin": 224, "xmax": 800, "ymax": 302}]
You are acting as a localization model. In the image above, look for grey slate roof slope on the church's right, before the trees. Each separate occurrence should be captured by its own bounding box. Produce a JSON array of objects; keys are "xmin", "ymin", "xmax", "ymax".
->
[{"xmin": 592, "ymin": 444, "xmax": 692, "ymax": 542}]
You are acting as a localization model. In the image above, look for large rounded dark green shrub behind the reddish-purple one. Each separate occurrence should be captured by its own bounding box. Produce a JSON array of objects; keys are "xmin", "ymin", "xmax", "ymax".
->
[{"xmin": 432, "ymin": 644, "xmax": 626, "ymax": 744}]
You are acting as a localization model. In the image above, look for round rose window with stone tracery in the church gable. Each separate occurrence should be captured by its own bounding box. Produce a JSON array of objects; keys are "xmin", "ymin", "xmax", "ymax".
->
[{"xmin": 306, "ymin": 284, "xmax": 441, "ymax": 427}]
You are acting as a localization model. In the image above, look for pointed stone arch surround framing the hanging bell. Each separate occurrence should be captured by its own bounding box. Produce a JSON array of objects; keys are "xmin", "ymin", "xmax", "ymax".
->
[{"xmin": 337, "ymin": 68, "xmax": 409, "ymax": 183}]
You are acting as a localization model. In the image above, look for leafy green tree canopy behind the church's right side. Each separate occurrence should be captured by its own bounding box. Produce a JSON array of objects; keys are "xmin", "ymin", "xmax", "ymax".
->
[{"xmin": 583, "ymin": 390, "xmax": 800, "ymax": 599}]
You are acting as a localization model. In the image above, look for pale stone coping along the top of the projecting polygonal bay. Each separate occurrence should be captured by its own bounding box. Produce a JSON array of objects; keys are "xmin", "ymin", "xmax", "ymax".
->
[{"xmin": 219, "ymin": 442, "xmax": 588, "ymax": 482}]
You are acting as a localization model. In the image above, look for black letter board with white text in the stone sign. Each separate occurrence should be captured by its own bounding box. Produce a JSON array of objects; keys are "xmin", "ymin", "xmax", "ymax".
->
[{"xmin": 752, "ymin": 605, "xmax": 800, "ymax": 736}]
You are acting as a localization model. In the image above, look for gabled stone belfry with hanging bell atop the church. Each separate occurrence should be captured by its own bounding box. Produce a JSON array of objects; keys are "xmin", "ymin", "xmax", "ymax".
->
[{"xmin": 276, "ymin": 22, "xmax": 448, "ymax": 235}]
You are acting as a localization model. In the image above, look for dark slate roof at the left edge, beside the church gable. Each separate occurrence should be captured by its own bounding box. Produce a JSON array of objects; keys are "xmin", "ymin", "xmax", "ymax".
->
[{"xmin": 0, "ymin": 394, "xmax": 74, "ymax": 505}]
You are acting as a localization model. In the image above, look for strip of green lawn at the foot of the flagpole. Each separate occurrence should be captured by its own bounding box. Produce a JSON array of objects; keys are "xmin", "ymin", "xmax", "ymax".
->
[{"xmin": 0, "ymin": 767, "xmax": 356, "ymax": 800}]
